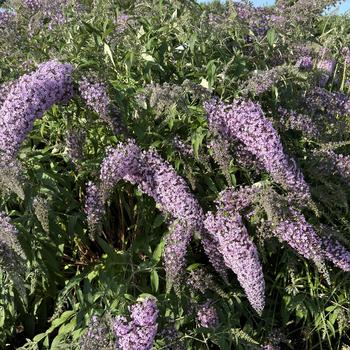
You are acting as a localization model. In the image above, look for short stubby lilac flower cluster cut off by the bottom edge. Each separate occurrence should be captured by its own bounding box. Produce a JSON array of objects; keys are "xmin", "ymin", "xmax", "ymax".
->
[{"xmin": 114, "ymin": 298, "xmax": 159, "ymax": 350}]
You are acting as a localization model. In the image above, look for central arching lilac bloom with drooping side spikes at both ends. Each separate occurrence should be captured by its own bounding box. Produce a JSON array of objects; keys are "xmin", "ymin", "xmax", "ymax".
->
[{"xmin": 85, "ymin": 140, "xmax": 223, "ymax": 280}]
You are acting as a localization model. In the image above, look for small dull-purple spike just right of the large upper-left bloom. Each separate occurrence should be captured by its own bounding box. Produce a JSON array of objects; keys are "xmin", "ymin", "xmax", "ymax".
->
[{"xmin": 79, "ymin": 77, "xmax": 122, "ymax": 134}]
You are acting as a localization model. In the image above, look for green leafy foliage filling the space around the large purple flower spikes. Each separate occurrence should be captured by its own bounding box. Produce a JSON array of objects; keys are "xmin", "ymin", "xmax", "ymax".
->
[{"xmin": 0, "ymin": 0, "xmax": 350, "ymax": 349}]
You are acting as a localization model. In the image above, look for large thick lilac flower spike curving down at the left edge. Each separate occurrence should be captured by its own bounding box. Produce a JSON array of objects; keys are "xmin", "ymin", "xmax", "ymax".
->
[{"xmin": 0, "ymin": 60, "xmax": 73, "ymax": 156}]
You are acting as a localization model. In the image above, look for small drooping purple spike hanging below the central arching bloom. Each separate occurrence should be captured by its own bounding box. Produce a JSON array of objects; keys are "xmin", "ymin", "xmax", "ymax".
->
[{"xmin": 164, "ymin": 222, "xmax": 192, "ymax": 283}]
